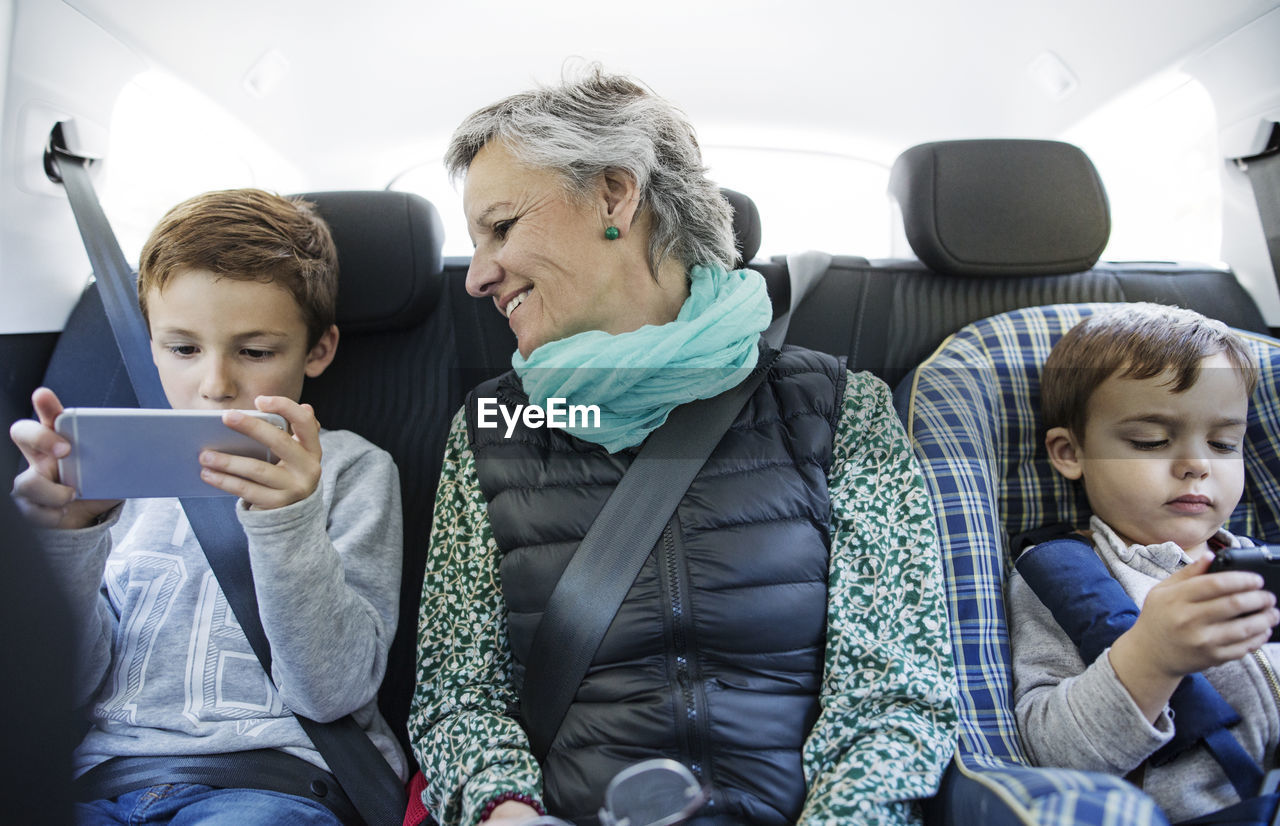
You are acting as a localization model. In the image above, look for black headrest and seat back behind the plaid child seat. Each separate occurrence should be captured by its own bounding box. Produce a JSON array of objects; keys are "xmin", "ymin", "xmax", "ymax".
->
[{"xmin": 774, "ymin": 141, "xmax": 1268, "ymax": 385}]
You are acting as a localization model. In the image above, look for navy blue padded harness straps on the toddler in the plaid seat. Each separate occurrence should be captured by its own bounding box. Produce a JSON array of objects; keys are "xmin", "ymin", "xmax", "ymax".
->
[{"xmin": 1015, "ymin": 538, "xmax": 1262, "ymax": 799}]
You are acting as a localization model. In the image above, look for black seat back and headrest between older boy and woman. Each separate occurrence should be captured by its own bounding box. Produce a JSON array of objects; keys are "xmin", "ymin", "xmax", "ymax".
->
[{"xmin": 291, "ymin": 202, "xmax": 515, "ymax": 759}]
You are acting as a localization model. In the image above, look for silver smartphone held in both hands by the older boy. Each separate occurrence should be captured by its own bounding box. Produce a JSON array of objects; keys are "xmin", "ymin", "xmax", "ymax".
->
[{"xmin": 54, "ymin": 407, "xmax": 285, "ymax": 499}]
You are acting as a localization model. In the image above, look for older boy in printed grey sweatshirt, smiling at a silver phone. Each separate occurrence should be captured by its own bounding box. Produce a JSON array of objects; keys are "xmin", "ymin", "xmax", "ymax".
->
[{"xmin": 10, "ymin": 190, "xmax": 406, "ymax": 826}]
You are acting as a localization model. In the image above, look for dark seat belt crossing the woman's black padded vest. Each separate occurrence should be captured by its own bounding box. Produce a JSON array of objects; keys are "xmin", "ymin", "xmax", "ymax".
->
[{"xmin": 521, "ymin": 352, "xmax": 777, "ymax": 761}]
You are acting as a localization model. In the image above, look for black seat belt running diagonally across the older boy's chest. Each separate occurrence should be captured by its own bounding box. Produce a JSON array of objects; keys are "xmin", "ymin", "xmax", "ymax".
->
[{"xmin": 45, "ymin": 123, "xmax": 406, "ymax": 826}]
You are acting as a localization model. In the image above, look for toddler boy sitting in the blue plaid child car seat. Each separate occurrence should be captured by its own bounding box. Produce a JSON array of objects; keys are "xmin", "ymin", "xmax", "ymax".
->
[{"xmin": 1010, "ymin": 305, "xmax": 1280, "ymax": 821}]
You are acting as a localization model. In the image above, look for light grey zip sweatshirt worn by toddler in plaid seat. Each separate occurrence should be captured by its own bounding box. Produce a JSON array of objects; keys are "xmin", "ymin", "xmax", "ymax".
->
[{"xmin": 1009, "ymin": 516, "xmax": 1280, "ymax": 822}]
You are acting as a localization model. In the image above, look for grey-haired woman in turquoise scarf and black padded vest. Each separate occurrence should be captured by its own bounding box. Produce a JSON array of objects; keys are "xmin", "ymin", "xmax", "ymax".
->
[{"xmin": 410, "ymin": 68, "xmax": 956, "ymax": 826}]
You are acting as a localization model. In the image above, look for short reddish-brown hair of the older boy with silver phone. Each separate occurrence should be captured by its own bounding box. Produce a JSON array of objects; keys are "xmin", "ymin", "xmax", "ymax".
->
[{"xmin": 138, "ymin": 190, "xmax": 338, "ymax": 350}]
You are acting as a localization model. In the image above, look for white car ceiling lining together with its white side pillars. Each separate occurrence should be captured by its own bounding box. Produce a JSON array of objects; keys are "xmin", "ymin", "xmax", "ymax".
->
[{"xmin": 0, "ymin": 0, "xmax": 1280, "ymax": 333}]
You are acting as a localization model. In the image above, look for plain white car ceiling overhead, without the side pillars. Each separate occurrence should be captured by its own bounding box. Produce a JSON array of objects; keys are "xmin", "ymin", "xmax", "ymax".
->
[{"xmin": 65, "ymin": 0, "xmax": 1280, "ymax": 186}]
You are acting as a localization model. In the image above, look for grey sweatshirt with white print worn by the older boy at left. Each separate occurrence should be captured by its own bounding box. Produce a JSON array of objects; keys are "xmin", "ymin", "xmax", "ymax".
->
[{"xmin": 41, "ymin": 430, "xmax": 407, "ymax": 779}]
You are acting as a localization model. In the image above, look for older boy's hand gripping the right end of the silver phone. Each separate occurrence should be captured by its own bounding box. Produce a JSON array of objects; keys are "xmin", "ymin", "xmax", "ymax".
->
[{"xmin": 200, "ymin": 396, "xmax": 321, "ymax": 511}]
